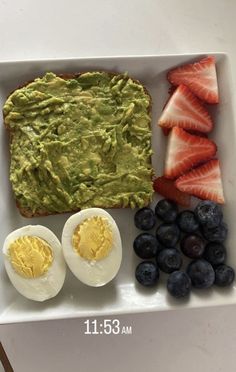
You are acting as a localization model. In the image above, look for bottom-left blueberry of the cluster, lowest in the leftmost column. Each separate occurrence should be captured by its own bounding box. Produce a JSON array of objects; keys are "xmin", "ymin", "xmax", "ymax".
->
[{"xmin": 135, "ymin": 261, "xmax": 159, "ymax": 287}]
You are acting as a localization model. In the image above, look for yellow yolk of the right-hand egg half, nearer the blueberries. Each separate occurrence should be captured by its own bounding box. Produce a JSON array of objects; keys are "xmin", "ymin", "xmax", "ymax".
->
[{"xmin": 72, "ymin": 216, "xmax": 112, "ymax": 260}]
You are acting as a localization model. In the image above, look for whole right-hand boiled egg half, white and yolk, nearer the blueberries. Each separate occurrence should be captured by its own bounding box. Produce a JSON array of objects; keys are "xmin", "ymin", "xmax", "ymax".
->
[{"xmin": 62, "ymin": 208, "xmax": 122, "ymax": 287}]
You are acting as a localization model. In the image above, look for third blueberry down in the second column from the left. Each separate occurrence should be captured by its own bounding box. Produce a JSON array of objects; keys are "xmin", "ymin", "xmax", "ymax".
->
[{"xmin": 157, "ymin": 248, "xmax": 183, "ymax": 273}]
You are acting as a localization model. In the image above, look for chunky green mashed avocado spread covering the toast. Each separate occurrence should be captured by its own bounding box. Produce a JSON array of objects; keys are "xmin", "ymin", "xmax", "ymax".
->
[{"xmin": 3, "ymin": 72, "xmax": 153, "ymax": 213}]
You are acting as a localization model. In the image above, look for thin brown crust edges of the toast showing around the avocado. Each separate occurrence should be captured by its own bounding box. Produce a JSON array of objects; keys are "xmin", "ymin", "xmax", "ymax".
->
[{"xmin": 3, "ymin": 70, "xmax": 152, "ymax": 218}]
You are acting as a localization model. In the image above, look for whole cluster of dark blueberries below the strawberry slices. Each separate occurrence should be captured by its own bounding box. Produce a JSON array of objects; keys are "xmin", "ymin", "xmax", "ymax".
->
[{"xmin": 133, "ymin": 199, "xmax": 235, "ymax": 298}]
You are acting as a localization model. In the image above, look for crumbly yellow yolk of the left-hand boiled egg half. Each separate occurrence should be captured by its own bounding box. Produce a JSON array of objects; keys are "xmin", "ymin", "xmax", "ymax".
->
[{"xmin": 8, "ymin": 236, "xmax": 53, "ymax": 279}]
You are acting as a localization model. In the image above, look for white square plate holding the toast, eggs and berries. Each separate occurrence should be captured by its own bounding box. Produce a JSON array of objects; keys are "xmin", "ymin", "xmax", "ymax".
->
[{"xmin": 0, "ymin": 53, "xmax": 236, "ymax": 324}]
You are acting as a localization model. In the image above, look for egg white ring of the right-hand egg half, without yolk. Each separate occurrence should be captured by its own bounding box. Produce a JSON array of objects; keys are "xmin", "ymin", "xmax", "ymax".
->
[{"xmin": 62, "ymin": 208, "xmax": 122, "ymax": 287}]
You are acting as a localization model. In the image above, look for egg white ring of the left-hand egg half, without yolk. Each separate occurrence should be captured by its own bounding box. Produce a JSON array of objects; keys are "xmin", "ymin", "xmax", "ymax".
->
[{"xmin": 3, "ymin": 225, "xmax": 66, "ymax": 301}]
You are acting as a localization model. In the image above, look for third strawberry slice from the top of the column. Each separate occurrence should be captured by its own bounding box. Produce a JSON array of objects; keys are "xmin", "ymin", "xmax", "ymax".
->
[{"xmin": 164, "ymin": 127, "xmax": 217, "ymax": 178}]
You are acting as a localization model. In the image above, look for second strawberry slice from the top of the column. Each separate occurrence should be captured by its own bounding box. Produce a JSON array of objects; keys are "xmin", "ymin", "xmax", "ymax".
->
[{"xmin": 158, "ymin": 84, "xmax": 213, "ymax": 133}]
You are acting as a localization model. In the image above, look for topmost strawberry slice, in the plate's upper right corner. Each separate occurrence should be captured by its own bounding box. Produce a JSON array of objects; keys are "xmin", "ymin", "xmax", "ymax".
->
[{"xmin": 167, "ymin": 56, "xmax": 219, "ymax": 103}]
